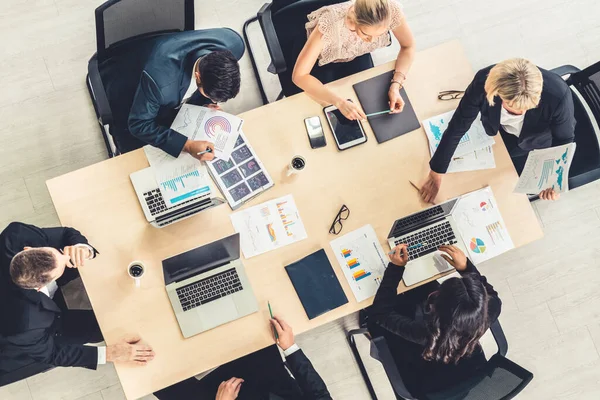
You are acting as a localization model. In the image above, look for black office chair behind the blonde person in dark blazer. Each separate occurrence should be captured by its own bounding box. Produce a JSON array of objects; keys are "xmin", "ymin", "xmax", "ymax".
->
[{"xmin": 552, "ymin": 62, "xmax": 600, "ymax": 190}]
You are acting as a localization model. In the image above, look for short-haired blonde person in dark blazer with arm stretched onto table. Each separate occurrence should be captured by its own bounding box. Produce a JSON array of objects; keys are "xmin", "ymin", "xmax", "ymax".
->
[{"xmin": 421, "ymin": 58, "xmax": 575, "ymax": 202}]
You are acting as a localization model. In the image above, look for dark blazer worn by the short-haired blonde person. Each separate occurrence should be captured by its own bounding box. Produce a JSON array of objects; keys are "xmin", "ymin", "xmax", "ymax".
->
[{"xmin": 429, "ymin": 65, "xmax": 575, "ymax": 174}]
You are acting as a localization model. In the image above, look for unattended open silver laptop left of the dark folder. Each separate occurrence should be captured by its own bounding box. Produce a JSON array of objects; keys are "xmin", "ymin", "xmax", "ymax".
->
[{"xmin": 162, "ymin": 233, "xmax": 258, "ymax": 338}]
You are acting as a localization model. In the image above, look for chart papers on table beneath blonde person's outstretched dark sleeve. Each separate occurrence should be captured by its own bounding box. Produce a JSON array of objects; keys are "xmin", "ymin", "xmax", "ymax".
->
[{"xmin": 423, "ymin": 110, "xmax": 496, "ymax": 172}]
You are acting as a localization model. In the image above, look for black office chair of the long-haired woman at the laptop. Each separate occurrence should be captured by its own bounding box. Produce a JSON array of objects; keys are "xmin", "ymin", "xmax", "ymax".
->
[{"xmin": 347, "ymin": 321, "xmax": 533, "ymax": 400}]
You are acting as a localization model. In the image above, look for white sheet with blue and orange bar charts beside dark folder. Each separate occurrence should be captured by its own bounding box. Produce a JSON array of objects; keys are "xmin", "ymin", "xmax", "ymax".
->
[{"xmin": 329, "ymin": 225, "xmax": 389, "ymax": 302}]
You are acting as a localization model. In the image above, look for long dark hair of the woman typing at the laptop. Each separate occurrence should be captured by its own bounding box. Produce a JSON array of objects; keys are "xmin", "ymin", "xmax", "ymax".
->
[{"xmin": 423, "ymin": 274, "xmax": 489, "ymax": 364}]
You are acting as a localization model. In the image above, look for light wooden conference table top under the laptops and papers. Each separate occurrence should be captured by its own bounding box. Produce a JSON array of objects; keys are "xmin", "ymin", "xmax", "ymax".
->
[{"xmin": 47, "ymin": 42, "xmax": 542, "ymax": 399}]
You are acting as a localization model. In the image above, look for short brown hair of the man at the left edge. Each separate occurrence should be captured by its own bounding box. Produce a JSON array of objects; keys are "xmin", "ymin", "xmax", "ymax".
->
[{"xmin": 10, "ymin": 249, "xmax": 56, "ymax": 289}]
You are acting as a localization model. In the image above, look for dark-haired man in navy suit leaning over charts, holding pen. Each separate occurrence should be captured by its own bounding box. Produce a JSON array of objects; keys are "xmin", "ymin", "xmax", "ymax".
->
[{"xmin": 103, "ymin": 28, "xmax": 245, "ymax": 160}]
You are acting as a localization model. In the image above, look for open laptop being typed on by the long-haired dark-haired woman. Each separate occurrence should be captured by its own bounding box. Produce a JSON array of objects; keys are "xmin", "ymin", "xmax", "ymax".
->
[{"xmin": 388, "ymin": 198, "xmax": 467, "ymax": 286}]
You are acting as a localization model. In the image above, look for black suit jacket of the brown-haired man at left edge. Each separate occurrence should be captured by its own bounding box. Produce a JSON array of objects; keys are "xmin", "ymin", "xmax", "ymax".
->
[{"xmin": 0, "ymin": 222, "xmax": 98, "ymax": 382}]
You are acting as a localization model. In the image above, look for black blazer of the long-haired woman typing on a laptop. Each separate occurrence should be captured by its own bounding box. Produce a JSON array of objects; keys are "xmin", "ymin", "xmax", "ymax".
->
[{"xmin": 369, "ymin": 260, "xmax": 502, "ymax": 397}]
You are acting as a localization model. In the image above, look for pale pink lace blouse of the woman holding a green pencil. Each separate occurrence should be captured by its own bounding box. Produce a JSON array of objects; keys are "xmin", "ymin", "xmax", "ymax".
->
[{"xmin": 306, "ymin": 0, "xmax": 404, "ymax": 66}]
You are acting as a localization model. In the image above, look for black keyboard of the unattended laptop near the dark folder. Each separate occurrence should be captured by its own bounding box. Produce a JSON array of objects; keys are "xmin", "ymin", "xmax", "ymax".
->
[{"xmin": 177, "ymin": 268, "xmax": 243, "ymax": 311}]
